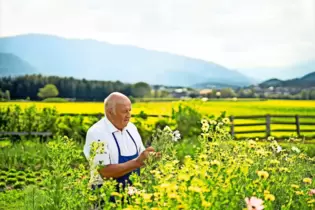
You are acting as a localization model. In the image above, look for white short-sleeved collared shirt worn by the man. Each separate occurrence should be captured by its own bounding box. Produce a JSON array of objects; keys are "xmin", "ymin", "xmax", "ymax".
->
[{"xmin": 83, "ymin": 117, "xmax": 145, "ymax": 184}]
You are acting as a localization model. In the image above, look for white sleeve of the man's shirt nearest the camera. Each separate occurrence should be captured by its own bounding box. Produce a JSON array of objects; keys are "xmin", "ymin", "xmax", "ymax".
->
[{"xmin": 83, "ymin": 130, "xmax": 110, "ymax": 166}]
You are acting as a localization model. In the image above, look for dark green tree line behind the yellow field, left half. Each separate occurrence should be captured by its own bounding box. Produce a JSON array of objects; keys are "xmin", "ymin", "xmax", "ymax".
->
[{"xmin": 0, "ymin": 74, "xmax": 151, "ymax": 101}]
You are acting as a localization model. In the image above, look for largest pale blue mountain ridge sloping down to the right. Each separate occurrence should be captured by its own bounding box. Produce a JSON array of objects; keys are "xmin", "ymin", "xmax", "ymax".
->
[{"xmin": 0, "ymin": 34, "xmax": 252, "ymax": 86}]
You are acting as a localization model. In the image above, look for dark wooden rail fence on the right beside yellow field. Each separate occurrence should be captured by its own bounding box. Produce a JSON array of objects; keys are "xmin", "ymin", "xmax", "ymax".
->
[{"xmin": 230, "ymin": 114, "xmax": 315, "ymax": 137}]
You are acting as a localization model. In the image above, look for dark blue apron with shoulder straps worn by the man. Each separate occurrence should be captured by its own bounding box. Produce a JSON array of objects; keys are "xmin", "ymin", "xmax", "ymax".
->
[{"xmin": 112, "ymin": 130, "xmax": 140, "ymax": 190}]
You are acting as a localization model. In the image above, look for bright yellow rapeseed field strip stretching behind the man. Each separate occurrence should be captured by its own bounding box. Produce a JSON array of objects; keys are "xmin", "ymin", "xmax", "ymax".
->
[{"xmin": 0, "ymin": 100, "xmax": 315, "ymax": 137}]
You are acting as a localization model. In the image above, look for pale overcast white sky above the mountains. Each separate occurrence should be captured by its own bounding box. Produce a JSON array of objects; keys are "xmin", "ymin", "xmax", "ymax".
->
[{"xmin": 0, "ymin": 0, "xmax": 315, "ymax": 79}]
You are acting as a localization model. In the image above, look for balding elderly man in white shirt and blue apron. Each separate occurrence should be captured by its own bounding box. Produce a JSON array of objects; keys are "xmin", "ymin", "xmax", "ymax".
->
[{"xmin": 84, "ymin": 92, "xmax": 154, "ymax": 194}]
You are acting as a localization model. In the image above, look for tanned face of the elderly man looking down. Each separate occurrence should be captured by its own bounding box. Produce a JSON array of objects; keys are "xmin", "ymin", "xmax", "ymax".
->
[{"xmin": 114, "ymin": 100, "xmax": 131, "ymax": 128}]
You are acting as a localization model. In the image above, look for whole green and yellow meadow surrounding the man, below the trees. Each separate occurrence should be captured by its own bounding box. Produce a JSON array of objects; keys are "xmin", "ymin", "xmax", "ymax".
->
[{"xmin": 0, "ymin": 100, "xmax": 315, "ymax": 210}]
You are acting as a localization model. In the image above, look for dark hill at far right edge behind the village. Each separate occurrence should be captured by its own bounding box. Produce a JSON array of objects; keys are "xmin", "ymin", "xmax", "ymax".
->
[{"xmin": 259, "ymin": 72, "xmax": 315, "ymax": 88}]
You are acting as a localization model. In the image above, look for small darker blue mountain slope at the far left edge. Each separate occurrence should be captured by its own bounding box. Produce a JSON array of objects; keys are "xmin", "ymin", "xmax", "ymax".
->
[{"xmin": 0, "ymin": 53, "xmax": 38, "ymax": 77}]
